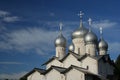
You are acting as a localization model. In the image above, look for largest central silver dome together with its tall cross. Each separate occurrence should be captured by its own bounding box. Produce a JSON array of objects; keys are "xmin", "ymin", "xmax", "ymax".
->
[{"xmin": 72, "ymin": 11, "xmax": 88, "ymax": 39}]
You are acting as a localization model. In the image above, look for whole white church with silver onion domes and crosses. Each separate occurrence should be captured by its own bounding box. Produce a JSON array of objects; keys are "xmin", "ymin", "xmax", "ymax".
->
[{"xmin": 21, "ymin": 12, "xmax": 115, "ymax": 80}]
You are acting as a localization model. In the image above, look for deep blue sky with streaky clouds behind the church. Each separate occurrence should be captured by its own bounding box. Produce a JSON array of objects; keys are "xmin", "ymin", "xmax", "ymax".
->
[{"xmin": 0, "ymin": 0, "xmax": 120, "ymax": 78}]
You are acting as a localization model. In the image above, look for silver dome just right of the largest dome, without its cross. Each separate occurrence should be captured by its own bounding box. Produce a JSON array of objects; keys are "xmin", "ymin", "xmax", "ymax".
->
[{"xmin": 85, "ymin": 31, "xmax": 98, "ymax": 44}]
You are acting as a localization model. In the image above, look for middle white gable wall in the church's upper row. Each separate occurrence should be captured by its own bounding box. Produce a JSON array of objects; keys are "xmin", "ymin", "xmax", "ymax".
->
[{"xmin": 63, "ymin": 54, "xmax": 81, "ymax": 68}]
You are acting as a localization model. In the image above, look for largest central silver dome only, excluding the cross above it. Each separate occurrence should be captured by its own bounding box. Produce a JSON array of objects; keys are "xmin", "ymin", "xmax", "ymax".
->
[{"xmin": 72, "ymin": 27, "xmax": 88, "ymax": 39}]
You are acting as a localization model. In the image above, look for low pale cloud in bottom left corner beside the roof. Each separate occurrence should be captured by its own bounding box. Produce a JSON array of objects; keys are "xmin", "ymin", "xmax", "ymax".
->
[{"xmin": 0, "ymin": 71, "xmax": 27, "ymax": 79}]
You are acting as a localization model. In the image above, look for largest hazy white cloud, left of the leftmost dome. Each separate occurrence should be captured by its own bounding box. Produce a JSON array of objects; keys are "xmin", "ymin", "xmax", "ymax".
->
[{"xmin": 0, "ymin": 27, "xmax": 57, "ymax": 55}]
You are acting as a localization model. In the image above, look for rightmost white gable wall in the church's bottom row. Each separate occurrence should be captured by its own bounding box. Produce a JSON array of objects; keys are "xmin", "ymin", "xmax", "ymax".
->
[{"xmin": 65, "ymin": 69, "xmax": 85, "ymax": 80}]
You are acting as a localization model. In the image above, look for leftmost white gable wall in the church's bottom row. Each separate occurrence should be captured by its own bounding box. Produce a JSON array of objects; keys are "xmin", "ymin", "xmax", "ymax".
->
[{"xmin": 27, "ymin": 71, "xmax": 45, "ymax": 80}]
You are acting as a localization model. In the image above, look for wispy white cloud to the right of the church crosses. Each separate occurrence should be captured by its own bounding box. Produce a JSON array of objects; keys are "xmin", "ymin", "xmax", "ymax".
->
[{"xmin": 92, "ymin": 20, "xmax": 117, "ymax": 28}]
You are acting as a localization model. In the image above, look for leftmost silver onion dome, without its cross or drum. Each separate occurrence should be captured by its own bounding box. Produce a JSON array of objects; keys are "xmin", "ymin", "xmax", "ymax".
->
[{"xmin": 55, "ymin": 34, "xmax": 66, "ymax": 47}]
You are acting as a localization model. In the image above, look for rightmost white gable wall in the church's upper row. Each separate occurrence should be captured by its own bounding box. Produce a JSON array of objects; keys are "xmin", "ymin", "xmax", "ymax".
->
[{"xmin": 82, "ymin": 57, "xmax": 98, "ymax": 74}]
